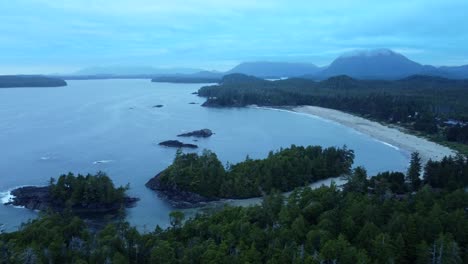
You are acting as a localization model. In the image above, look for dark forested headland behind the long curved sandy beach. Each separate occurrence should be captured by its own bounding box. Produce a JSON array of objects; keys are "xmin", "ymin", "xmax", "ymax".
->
[{"xmin": 198, "ymin": 74, "xmax": 468, "ymax": 151}]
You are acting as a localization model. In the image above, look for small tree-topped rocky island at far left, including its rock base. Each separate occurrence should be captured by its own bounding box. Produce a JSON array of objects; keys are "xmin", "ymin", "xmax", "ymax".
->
[{"xmin": 6, "ymin": 172, "xmax": 139, "ymax": 214}]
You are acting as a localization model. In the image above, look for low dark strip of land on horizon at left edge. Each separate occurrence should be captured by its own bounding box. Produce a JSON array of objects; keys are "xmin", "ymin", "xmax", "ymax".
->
[{"xmin": 0, "ymin": 75, "xmax": 67, "ymax": 88}]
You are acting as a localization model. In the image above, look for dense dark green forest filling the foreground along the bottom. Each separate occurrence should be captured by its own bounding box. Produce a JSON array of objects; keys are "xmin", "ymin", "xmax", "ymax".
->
[{"xmin": 0, "ymin": 156, "xmax": 468, "ymax": 264}]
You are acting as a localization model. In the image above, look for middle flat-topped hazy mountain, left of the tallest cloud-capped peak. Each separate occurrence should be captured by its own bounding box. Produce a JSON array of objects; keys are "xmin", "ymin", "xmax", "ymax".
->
[{"xmin": 226, "ymin": 62, "xmax": 320, "ymax": 78}]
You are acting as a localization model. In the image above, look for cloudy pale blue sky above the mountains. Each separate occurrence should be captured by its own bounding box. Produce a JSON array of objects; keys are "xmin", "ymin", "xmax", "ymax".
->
[{"xmin": 0, "ymin": 0, "xmax": 468, "ymax": 74}]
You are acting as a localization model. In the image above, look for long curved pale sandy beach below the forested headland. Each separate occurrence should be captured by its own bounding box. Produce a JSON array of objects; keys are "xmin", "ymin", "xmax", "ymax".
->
[{"xmin": 291, "ymin": 106, "xmax": 456, "ymax": 163}]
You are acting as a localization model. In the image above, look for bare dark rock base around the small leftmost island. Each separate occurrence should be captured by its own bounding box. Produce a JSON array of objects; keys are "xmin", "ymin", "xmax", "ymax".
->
[{"xmin": 5, "ymin": 186, "xmax": 139, "ymax": 214}]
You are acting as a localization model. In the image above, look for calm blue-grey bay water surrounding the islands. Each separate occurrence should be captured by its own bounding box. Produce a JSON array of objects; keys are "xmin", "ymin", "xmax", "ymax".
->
[{"xmin": 0, "ymin": 80, "xmax": 408, "ymax": 230}]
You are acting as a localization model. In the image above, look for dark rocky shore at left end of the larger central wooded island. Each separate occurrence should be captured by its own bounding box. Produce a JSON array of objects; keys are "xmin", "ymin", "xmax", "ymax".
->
[{"xmin": 145, "ymin": 174, "xmax": 219, "ymax": 209}]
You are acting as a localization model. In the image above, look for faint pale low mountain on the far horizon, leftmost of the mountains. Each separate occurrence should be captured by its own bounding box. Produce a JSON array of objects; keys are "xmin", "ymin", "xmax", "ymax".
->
[{"xmin": 73, "ymin": 66, "xmax": 200, "ymax": 76}]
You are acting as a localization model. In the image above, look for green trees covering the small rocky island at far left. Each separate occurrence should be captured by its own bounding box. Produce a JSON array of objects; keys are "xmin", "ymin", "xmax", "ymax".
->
[{"xmin": 49, "ymin": 172, "xmax": 128, "ymax": 208}]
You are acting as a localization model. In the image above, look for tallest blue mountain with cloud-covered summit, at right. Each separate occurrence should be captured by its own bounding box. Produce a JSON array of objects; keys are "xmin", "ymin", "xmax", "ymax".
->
[{"xmin": 319, "ymin": 49, "xmax": 432, "ymax": 79}]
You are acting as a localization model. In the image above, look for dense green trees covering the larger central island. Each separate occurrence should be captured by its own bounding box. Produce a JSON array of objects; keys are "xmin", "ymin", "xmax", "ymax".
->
[{"xmin": 152, "ymin": 145, "xmax": 354, "ymax": 198}]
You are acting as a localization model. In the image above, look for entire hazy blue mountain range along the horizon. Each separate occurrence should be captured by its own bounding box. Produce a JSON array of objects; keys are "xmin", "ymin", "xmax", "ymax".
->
[{"xmin": 65, "ymin": 49, "xmax": 468, "ymax": 80}]
